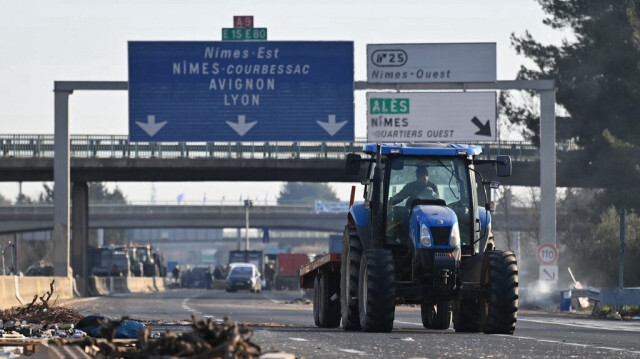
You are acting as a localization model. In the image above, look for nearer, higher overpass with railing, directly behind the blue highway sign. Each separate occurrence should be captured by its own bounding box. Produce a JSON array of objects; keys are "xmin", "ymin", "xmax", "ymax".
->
[{"xmin": 0, "ymin": 135, "xmax": 588, "ymax": 187}]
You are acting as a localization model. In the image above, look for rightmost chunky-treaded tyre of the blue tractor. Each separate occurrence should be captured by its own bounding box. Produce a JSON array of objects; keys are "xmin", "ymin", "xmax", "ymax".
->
[{"xmin": 481, "ymin": 251, "xmax": 518, "ymax": 334}]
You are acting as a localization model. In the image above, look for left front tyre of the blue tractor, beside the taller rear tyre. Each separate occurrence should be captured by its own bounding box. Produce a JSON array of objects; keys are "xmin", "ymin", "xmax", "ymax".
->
[{"xmin": 358, "ymin": 248, "xmax": 396, "ymax": 332}]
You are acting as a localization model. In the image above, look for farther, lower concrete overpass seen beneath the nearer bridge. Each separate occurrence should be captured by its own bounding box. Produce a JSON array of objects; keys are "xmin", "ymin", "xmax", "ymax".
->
[{"xmin": 0, "ymin": 204, "xmax": 538, "ymax": 234}]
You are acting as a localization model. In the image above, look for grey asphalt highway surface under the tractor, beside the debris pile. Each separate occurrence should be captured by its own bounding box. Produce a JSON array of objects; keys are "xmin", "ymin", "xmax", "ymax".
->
[{"xmin": 70, "ymin": 289, "xmax": 640, "ymax": 358}]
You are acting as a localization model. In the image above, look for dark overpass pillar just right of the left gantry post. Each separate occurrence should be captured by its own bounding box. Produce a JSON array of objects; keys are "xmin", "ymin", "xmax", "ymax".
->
[{"xmin": 71, "ymin": 182, "xmax": 89, "ymax": 295}]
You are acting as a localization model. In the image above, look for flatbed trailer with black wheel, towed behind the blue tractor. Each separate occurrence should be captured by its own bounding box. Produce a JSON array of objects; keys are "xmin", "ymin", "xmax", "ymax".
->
[{"xmin": 299, "ymin": 253, "xmax": 341, "ymax": 328}]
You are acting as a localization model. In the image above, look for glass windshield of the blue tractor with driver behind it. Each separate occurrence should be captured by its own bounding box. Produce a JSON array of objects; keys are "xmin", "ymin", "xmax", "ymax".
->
[{"xmin": 386, "ymin": 157, "xmax": 473, "ymax": 245}]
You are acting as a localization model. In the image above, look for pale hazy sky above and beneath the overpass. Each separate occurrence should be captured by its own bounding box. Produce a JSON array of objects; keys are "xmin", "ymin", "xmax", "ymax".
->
[{"xmin": 0, "ymin": 0, "xmax": 570, "ymax": 204}]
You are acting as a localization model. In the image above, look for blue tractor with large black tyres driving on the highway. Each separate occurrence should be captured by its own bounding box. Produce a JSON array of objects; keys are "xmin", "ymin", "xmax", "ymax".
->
[{"xmin": 342, "ymin": 144, "xmax": 518, "ymax": 334}]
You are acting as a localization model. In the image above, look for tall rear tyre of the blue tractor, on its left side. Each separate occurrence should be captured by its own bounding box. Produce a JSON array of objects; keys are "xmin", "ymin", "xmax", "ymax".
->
[{"xmin": 340, "ymin": 225, "xmax": 362, "ymax": 330}]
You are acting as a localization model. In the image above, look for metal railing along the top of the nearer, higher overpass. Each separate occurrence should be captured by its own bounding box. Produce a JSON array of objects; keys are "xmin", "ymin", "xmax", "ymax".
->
[{"xmin": 0, "ymin": 134, "xmax": 579, "ymax": 161}]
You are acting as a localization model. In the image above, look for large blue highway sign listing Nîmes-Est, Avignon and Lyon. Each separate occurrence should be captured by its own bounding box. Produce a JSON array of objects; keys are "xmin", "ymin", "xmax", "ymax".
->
[{"xmin": 129, "ymin": 41, "xmax": 354, "ymax": 141}]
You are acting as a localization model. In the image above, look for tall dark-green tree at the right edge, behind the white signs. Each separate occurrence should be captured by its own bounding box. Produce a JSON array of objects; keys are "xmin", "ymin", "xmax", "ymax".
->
[{"xmin": 510, "ymin": 0, "xmax": 640, "ymax": 214}]
